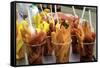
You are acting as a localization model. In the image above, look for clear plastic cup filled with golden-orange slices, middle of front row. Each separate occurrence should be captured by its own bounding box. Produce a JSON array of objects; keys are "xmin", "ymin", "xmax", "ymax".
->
[{"xmin": 52, "ymin": 41, "xmax": 71, "ymax": 63}]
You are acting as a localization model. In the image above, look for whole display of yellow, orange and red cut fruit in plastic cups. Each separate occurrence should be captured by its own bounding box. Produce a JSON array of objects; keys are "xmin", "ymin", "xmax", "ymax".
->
[{"xmin": 16, "ymin": 4, "xmax": 96, "ymax": 65}]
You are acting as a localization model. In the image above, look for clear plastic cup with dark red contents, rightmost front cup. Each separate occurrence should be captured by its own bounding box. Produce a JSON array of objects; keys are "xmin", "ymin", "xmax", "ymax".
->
[{"xmin": 80, "ymin": 42, "xmax": 95, "ymax": 62}]
